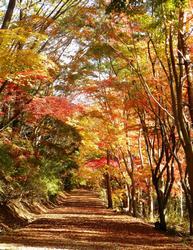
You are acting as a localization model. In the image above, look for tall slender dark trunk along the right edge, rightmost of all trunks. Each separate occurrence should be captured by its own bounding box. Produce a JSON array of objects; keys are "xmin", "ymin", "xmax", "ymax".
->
[{"xmin": 174, "ymin": 8, "xmax": 193, "ymax": 235}]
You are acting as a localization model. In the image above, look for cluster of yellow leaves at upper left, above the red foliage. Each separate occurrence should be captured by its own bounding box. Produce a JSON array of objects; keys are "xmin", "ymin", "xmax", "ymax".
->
[{"xmin": 0, "ymin": 27, "xmax": 58, "ymax": 78}]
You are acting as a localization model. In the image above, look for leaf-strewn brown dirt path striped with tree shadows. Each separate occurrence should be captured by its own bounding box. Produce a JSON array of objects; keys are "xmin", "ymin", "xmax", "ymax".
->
[{"xmin": 0, "ymin": 190, "xmax": 193, "ymax": 250}]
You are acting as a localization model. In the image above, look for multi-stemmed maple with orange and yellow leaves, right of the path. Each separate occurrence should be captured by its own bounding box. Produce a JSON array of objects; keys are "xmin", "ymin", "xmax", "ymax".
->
[{"xmin": 59, "ymin": 2, "xmax": 192, "ymax": 234}]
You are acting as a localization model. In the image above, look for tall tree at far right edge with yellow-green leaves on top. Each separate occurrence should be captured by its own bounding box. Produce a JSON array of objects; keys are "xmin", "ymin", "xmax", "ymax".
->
[{"xmin": 104, "ymin": 1, "xmax": 193, "ymax": 234}]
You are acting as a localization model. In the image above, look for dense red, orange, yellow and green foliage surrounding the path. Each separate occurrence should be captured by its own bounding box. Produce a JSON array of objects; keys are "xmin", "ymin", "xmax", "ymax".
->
[{"xmin": 0, "ymin": 0, "xmax": 193, "ymax": 234}]
